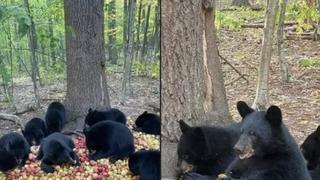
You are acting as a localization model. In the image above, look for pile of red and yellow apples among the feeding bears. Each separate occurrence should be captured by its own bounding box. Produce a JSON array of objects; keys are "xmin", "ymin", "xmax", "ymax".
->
[{"xmin": 0, "ymin": 128, "xmax": 160, "ymax": 180}]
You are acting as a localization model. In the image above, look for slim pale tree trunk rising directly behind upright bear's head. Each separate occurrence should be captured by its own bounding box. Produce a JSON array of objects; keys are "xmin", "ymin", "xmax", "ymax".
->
[{"xmin": 252, "ymin": 0, "xmax": 279, "ymax": 110}]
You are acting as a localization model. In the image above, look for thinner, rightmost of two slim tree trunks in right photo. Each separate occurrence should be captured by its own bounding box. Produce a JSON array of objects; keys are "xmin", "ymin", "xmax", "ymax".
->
[{"xmin": 277, "ymin": 0, "xmax": 291, "ymax": 82}]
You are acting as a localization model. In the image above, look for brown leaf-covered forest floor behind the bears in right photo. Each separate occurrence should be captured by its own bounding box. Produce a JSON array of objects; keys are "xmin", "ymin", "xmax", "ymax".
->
[{"xmin": 218, "ymin": 29, "xmax": 320, "ymax": 144}]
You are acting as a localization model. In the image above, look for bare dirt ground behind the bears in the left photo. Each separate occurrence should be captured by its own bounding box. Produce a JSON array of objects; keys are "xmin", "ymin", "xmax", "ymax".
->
[{"xmin": 0, "ymin": 73, "xmax": 160, "ymax": 135}]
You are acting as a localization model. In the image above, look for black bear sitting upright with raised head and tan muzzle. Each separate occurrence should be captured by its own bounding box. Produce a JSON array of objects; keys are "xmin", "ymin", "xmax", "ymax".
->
[{"xmin": 226, "ymin": 101, "xmax": 311, "ymax": 180}]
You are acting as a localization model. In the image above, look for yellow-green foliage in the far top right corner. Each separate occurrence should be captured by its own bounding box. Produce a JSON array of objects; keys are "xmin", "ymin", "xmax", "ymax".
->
[{"xmin": 286, "ymin": 1, "xmax": 320, "ymax": 32}]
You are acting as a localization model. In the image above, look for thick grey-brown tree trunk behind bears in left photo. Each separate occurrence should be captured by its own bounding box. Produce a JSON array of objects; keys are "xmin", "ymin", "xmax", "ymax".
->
[{"xmin": 64, "ymin": 0, "xmax": 110, "ymax": 130}]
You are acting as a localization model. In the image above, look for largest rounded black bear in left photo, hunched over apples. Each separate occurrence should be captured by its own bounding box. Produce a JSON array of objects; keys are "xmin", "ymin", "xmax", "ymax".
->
[{"xmin": 84, "ymin": 121, "xmax": 134, "ymax": 162}]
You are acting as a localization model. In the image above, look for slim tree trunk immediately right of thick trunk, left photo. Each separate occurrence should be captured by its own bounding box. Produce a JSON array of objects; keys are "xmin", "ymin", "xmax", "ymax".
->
[{"xmin": 108, "ymin": 0, "xmax": 118, "ymax": 64}]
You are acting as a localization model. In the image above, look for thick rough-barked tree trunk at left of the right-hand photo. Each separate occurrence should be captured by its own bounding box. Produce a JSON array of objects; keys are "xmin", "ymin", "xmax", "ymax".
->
[{"xmin": 161, "ymin": 0, "xmax": 230, "ymax": 178}]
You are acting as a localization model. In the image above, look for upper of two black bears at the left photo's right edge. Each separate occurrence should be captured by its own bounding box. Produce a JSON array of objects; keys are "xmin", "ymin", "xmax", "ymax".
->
[{"xmin": 134, "ymin": 111, "xmax": 161, "ymax": 135}]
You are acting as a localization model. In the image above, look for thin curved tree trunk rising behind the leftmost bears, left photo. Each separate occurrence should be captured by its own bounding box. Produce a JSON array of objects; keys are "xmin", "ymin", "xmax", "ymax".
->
[{"xmin": 24, "ymin": 0, "xmax": 40, "ymax": 108}]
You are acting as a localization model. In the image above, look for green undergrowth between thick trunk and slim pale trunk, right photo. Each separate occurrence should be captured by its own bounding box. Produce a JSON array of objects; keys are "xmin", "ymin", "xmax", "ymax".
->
[{"xmin": 216, "ymin": 7, "xmax": 264, "ymax": 29}]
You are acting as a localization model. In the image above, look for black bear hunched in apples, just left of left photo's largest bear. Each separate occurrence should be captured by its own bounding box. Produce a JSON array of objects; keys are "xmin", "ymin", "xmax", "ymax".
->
[{"xmin": 37, "ymin": 132, "xmax": 80, "ymax": 173}]
